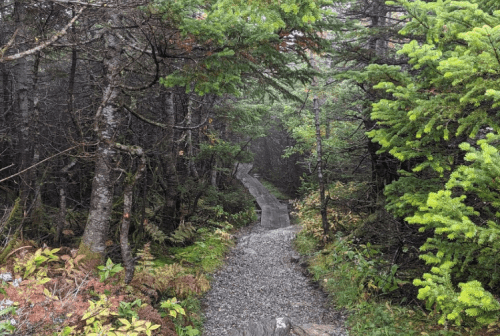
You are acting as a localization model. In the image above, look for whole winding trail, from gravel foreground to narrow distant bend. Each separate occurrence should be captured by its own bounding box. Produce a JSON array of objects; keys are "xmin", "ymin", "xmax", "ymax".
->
[{"xmin": 203, "ymin": 164, "xmax": 347, "ymax": 336}]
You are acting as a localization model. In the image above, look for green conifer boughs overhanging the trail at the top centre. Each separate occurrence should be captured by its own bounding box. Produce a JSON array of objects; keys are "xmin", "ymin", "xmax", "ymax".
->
[{"xmin": 151, "ymin": 0, "xmax": 328, "ymax": 95}]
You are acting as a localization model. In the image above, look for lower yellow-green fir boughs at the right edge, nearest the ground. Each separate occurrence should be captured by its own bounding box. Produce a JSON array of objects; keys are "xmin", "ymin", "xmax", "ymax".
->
[{"xmin": 407, "ymin": 133, "xmax": 500, "ymax": 324}]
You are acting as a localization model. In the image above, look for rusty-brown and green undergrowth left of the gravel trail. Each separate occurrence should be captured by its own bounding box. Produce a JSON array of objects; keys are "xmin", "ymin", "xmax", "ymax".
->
[{"xmin": 0, "ymin": 196, "xmax": 255, "ymax": 336}]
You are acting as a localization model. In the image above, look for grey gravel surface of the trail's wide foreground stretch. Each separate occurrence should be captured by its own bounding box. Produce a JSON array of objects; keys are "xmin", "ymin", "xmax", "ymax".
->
[{"xmin": 202, "ymin": 218, "xmax": 347, "ymax": 336}]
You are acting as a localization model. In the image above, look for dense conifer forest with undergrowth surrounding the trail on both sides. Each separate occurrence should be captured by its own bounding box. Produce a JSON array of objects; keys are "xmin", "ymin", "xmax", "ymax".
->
[{"xmin": 0, "ymin": 0, "xmax": 500, "ymax": 336}]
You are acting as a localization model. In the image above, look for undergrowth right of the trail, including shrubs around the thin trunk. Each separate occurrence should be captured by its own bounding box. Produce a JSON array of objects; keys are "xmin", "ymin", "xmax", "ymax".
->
[{"xmin": 294, "ymin": 183, "xmax": 500, "ymax": 336}]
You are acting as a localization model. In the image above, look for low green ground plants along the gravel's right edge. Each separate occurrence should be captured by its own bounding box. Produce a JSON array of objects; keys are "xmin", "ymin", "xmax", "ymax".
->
[{"xmin": 294, "ymin": 198, "xmax": 476, "ymax": 336}]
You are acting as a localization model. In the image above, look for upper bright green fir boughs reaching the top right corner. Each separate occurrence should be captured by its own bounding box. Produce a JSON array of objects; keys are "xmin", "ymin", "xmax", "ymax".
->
[{"xmin": 367, "ymin": 0, "xmax": 500, "ymax": 216}]
